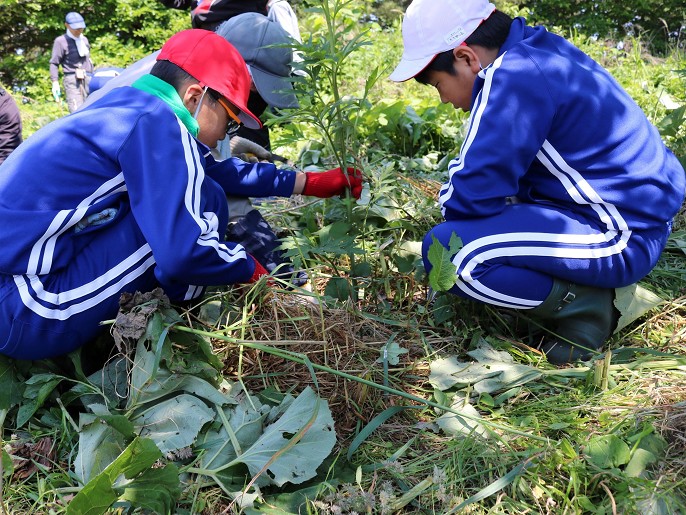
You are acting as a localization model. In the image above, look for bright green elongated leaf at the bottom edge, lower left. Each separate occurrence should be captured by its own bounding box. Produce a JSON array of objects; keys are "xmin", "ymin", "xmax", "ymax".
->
[{"xmin": 67, "ymin": 438, "xmax": 161, "ymax": 515}]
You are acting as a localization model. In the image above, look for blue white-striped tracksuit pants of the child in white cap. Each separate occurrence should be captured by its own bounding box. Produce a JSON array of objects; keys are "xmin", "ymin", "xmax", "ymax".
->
[{"xmin": 422, "ymin": 204, "xmax": 671, "ymax": 309}]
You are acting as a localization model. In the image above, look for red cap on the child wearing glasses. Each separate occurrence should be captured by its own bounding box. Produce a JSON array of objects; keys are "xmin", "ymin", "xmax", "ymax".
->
[{"xmin": 157, "ymin": 29, "xmax": 262, "ymax": 129}]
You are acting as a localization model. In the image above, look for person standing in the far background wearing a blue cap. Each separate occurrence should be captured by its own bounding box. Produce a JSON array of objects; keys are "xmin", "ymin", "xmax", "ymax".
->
[{"xmin": 50, "ymin": 12, "xmax": 93, "ymax": 113}]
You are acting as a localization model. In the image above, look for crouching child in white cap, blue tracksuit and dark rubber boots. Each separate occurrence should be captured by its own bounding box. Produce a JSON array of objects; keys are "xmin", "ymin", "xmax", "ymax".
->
[{"xmin": 391, "ymin": 0, "xmax": 684, "ymax": 363}]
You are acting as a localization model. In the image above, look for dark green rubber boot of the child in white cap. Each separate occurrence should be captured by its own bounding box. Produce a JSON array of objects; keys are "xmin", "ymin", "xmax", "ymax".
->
[{"xmin": 528, "ymin": 279, "xmax": 618, "ymax": 365}]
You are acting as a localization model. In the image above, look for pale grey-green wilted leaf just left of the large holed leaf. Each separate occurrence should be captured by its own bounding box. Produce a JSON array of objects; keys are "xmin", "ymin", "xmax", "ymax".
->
[{"xmin": 132, "ymin": 394, "xmax": 214, "ymax": 454}]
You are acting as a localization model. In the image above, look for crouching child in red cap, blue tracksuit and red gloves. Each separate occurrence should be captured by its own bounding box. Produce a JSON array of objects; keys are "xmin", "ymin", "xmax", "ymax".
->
[{"xmin": 0, "ymin": 29, "xmax": 361, "ymax": 359}]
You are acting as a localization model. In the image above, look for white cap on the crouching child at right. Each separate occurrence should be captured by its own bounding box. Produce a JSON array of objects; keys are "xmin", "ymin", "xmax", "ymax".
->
[{"xmin": 390, "ymin": 0, "xmax": 495, "ymax": 82}]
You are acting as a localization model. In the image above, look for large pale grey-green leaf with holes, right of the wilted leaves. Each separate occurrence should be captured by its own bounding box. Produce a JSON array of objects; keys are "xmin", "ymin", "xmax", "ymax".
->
[{"xmin": 236, "ymin": 387, "xmax": 336, "ymax": 486}]
